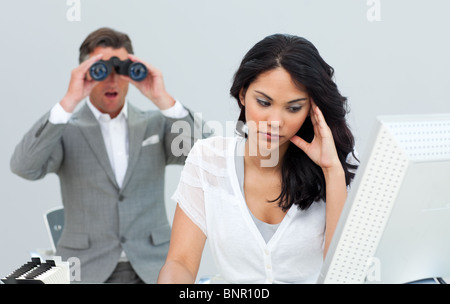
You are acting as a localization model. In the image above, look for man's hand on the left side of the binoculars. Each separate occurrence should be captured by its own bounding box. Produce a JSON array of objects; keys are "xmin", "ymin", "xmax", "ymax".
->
[{"xmin": 60, "ymin": 54, "xmax": 103, "ymax": 113}]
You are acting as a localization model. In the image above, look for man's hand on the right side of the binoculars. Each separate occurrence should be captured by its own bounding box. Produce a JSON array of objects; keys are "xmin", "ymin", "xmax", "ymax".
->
[{"xmin": 120, "ymin": 54, "xmax": 175, "ymax": 110}]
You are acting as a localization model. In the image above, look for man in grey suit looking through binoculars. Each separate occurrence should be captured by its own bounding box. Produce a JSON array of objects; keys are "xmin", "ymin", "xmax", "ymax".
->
[{"xmin": 11, "ymin": 28, "xmax": 207, "ymax": 283}]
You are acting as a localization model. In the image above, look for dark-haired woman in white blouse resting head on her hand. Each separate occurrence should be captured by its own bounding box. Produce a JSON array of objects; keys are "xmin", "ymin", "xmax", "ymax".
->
[{"xmin": 158, "ymin": 34, "xmax": 357, "ymax": 283}]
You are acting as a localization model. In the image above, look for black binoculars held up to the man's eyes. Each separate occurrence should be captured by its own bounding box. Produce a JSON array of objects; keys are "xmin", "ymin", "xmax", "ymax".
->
[{"xmin": 89, "ymin": 57, "xmax": 147, "ymax": 81}]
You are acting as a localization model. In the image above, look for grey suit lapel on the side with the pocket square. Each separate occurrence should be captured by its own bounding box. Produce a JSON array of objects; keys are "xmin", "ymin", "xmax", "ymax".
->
[{"xmin": 122, "ymin": 103, "xmax": 147, "ymax": 189}]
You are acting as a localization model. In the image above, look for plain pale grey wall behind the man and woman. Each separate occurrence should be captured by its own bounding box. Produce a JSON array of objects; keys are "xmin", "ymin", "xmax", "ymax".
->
[{"xmin": 0, "ymin": 0, "xmax": 450, "ymax": 277}]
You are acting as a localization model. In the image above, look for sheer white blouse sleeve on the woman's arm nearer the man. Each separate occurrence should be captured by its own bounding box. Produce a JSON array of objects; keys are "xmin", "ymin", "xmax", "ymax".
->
[{"xmin": 172, "ymin": 140, "xmax": 207, "ymax": 235}]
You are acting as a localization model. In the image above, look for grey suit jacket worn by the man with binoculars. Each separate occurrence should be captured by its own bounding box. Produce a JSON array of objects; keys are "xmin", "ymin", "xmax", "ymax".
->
[{"xmin": 11, "ymin": 104, "xmax": 207, "ymax": 283}]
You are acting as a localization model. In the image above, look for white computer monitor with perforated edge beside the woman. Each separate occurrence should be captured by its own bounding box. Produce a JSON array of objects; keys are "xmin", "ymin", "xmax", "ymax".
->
[{"xmin": 318, "ymin": 114, "xmax": 450, "ymax": 284}]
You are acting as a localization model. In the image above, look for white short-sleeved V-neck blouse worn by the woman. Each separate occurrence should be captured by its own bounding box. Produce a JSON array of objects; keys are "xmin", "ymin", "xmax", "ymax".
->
[{"xmin": 172, "ymin": 136, "xmax": 325, "ymax": 284}]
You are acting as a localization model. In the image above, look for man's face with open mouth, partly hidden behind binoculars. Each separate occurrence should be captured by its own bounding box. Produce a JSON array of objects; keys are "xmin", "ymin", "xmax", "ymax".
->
[{"xmin": 89, "ymin": 47, "xmax": 129, "ymax": 118}]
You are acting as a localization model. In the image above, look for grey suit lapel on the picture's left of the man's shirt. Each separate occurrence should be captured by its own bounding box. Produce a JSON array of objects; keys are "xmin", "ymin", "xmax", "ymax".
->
[{"xmin": 74, "ymin": 104, "xmax": 119, "ymax": 188}]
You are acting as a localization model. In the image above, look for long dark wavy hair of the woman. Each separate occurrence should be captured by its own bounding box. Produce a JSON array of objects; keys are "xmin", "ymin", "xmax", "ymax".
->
[{"xmin": 230, "ymin": 34, "xmax": 357, "ymax": 211}]
